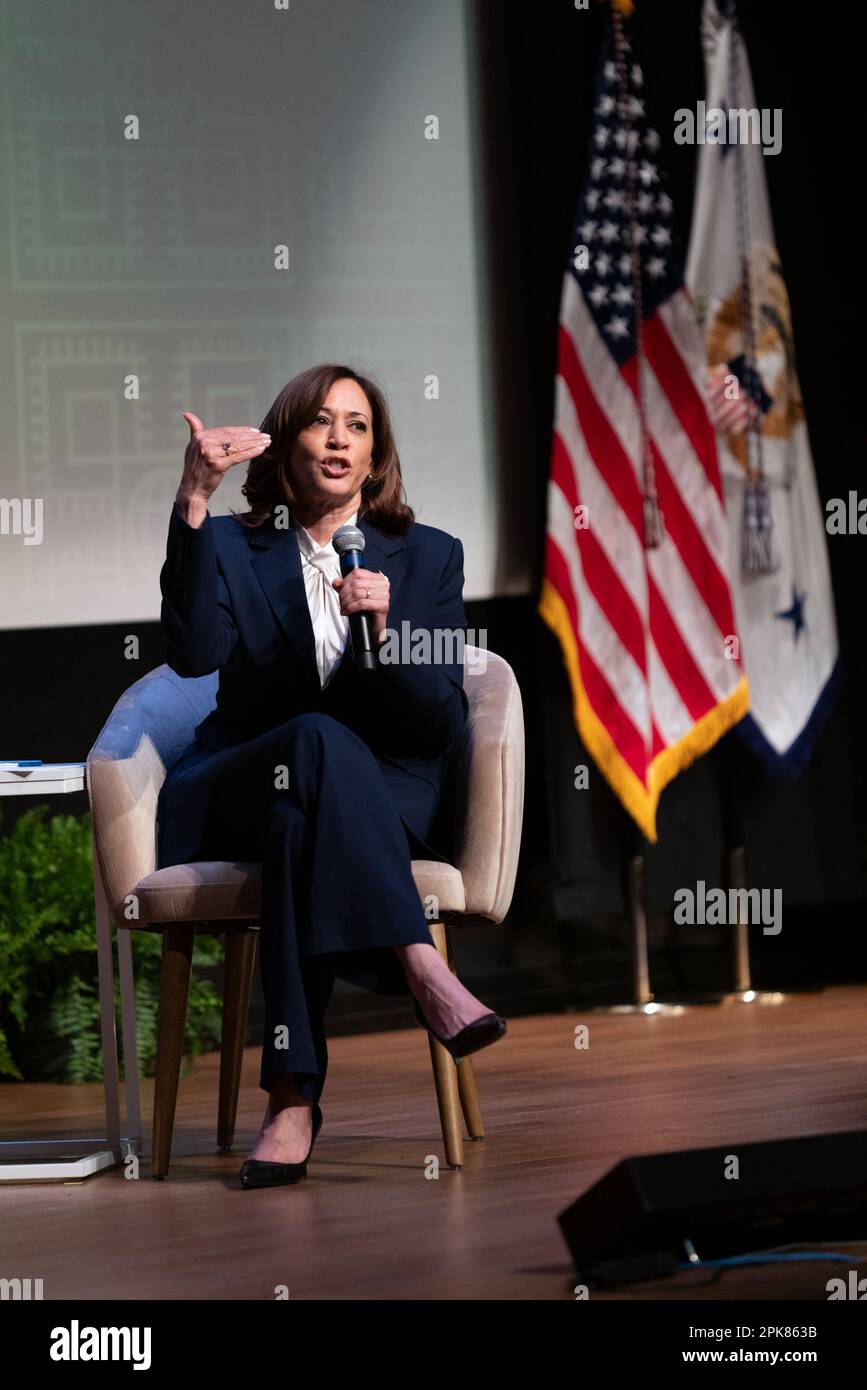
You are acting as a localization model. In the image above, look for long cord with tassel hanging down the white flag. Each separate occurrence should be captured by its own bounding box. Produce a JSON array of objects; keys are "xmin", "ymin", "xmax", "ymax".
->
[{"xmin": 728, "ymin": 6, "xmax": 777, "ymax": 574}]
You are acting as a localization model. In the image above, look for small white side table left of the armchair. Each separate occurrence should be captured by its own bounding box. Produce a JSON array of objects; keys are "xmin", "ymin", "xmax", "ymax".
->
[{"xmin": 0, "ymin": 762, "xmax": 142, "ymax": 1183}]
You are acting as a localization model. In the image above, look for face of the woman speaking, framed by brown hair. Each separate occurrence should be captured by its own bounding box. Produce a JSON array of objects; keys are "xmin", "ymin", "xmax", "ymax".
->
[{"xmin": 289, "ymin": 378, "xmax": 374, "ymax": 513}]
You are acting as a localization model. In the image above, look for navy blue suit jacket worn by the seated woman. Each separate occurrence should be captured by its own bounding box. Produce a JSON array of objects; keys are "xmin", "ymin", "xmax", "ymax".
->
[{"xmin": 158, "ymin": 507, "xmax": 468, "ymax": 866}]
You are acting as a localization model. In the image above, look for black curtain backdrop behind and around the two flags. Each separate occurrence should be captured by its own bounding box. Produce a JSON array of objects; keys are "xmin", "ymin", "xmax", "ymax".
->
[{"xmin": 479, "ymin": 0, "xmax": 867, "ymax": 989}]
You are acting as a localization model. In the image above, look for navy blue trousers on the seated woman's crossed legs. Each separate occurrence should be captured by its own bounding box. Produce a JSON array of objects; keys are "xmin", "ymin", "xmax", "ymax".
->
[{"xmin": 187, "ymin": 713, "xmax": 432, "ymax": 1101}]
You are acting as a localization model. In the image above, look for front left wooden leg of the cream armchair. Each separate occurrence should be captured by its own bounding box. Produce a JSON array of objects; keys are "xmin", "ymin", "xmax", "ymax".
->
[{"xmin": 151, "ymin": 922, "xmax": 196, "ymax": 1179}]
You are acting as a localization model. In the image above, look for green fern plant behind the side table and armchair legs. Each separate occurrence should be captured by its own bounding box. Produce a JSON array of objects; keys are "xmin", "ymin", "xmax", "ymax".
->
[{"xmin": 0, "ymin": 806, "xmax": 222, "ymax": 1084}]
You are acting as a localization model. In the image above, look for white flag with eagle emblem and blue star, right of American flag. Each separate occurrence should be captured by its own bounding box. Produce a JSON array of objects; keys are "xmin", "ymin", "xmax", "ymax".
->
[{"xmin": 686, "ymin": 0, "xmax": 838, "ymax": 771}]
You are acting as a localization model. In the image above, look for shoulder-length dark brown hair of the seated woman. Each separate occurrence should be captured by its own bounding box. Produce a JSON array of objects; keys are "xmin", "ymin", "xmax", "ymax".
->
[{"xmin": 238, "ymin": 361, "xmax": 415, "ymax": 535}]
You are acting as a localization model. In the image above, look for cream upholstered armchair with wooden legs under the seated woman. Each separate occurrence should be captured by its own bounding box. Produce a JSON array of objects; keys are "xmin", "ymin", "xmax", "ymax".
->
[{"xmin": 88, "ymin": 646, "xmax": 524, "ymax": 1177}]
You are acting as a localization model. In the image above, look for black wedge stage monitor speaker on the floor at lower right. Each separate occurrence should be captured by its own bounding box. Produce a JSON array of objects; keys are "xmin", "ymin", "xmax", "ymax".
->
[{"xmin": 557, "ymin": 1130, "xmax": 867, "ymax": 1284}]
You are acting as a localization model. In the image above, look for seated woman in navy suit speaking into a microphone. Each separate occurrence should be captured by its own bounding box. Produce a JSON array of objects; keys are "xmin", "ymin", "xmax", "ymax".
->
[{"xmin": 158, "ymin": 364, "xmax": 506, "ymax": 1187}]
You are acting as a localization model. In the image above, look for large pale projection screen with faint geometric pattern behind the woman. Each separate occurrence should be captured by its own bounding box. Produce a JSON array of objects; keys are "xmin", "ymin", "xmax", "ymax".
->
[{"xmin": 0, "ymin": 0, "xmax": 514, "ymax": 628}]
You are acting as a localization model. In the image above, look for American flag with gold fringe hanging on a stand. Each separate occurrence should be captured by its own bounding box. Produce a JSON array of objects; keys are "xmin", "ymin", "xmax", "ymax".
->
[{"xmin": 539, "ymin": 28, "xmax": 749, "ymax": 841}]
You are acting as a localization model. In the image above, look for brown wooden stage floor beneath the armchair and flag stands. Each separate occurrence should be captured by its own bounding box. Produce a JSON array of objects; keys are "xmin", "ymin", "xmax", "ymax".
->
[{"xmin": 0, "ymin": 986, "xmax": 867, "ymax": 1301}]
